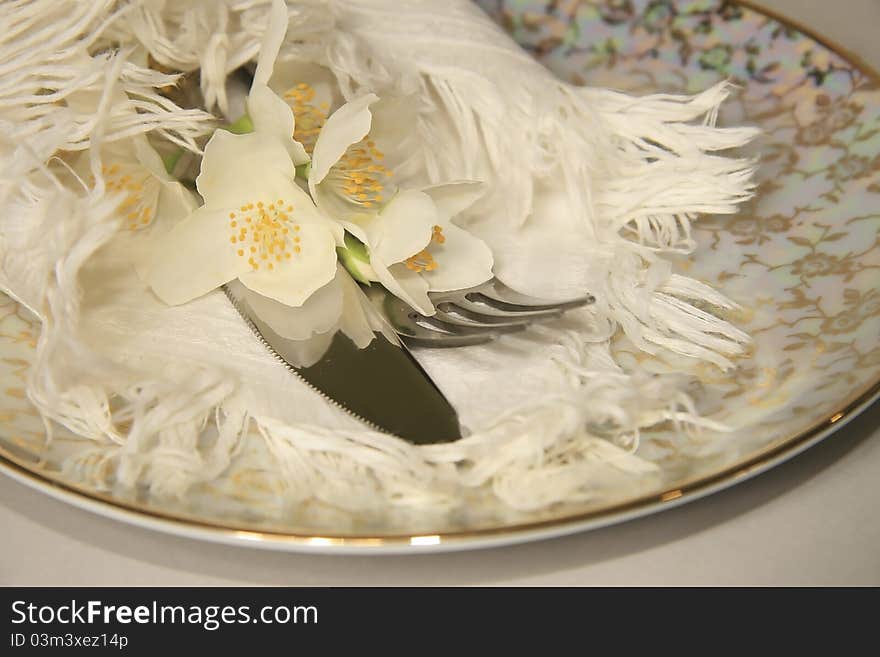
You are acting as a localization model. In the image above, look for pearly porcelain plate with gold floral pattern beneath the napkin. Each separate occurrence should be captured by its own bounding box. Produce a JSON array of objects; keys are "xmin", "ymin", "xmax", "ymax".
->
[{"xmin": 0, "ymin": 0, "xmax": 880, "ymax": 550}]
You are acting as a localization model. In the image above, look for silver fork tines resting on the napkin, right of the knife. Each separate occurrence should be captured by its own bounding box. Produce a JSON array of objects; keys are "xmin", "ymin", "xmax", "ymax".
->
[{"xmin": 365, "ymin": 278, "xmax": 596, "ymax": 347}]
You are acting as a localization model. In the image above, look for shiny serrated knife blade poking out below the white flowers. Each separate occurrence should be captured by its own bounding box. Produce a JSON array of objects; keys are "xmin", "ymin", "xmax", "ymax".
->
[{"xmin": 223, "ymin": 284, "xmax": 461, "ymax": 445}]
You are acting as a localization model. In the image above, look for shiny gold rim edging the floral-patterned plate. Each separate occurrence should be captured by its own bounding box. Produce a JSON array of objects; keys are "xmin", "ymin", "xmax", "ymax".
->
[{"xmin": 0, "ymin": 0, "xmax": 880, "ymax": 553}]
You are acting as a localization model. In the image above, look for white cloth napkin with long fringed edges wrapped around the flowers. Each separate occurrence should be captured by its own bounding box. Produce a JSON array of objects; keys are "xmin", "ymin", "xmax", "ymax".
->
[{"xmin": 0, "ymin": 0, "xmax": 754, "ymax": 509}]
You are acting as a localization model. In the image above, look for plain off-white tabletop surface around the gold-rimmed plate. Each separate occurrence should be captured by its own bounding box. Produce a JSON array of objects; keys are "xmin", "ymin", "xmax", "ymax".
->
[{"xmin": 0, "ymin": 0, "xmax": 880, "ymax": 586}]
